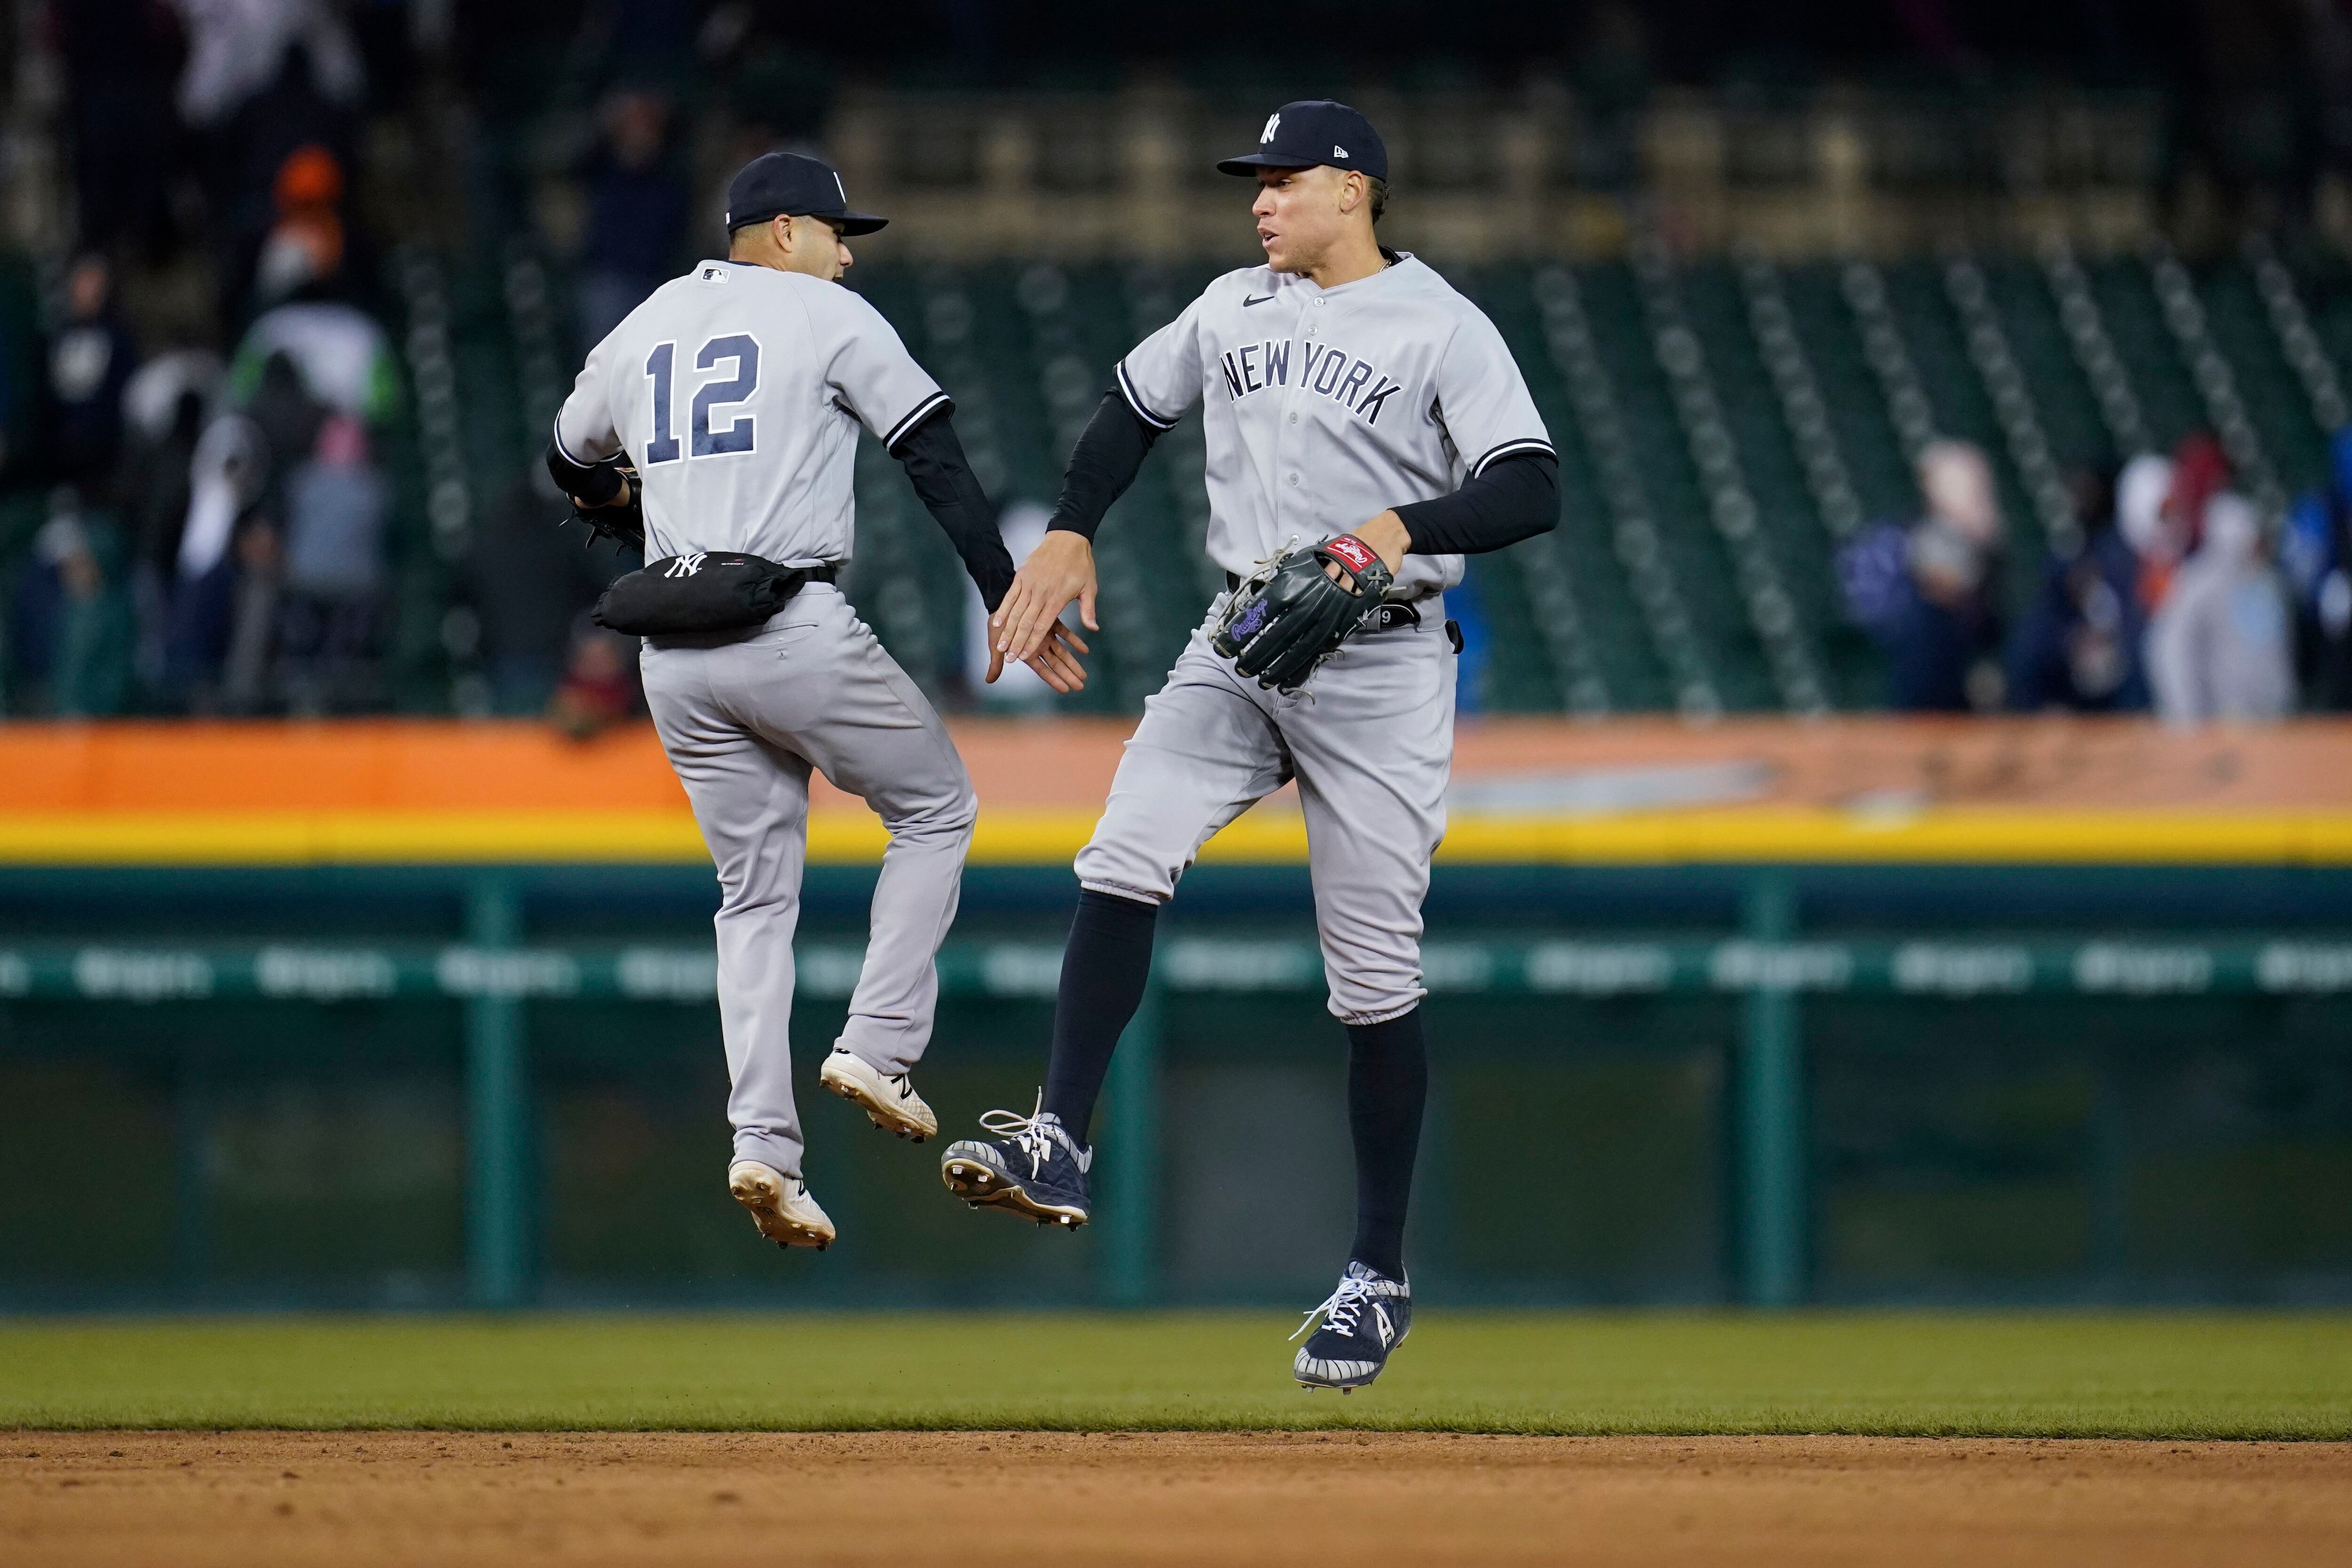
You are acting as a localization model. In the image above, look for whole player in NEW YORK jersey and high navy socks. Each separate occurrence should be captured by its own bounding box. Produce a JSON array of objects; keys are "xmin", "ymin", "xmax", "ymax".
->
[{"xmin": 941, "ymin": 101, "xmax": 1559, "ymax": 1389}]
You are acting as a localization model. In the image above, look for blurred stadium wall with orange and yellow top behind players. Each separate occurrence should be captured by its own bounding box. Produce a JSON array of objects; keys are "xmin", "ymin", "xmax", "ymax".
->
[{"xmin": 0, "ymin": 719, "xmax": 2352, "ymax": 1309}]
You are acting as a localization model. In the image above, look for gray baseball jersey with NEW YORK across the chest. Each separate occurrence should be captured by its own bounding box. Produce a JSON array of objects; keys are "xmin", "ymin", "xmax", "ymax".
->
[{"xmin": 1117, "ymin": 254, "xmax": 1552, "ymax": 597}]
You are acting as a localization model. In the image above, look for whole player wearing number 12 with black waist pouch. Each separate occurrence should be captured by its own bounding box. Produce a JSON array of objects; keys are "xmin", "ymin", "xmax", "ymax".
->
[{"xmin": 548, "ymin": 153, "xmax": 1084, "ymax": 1248}]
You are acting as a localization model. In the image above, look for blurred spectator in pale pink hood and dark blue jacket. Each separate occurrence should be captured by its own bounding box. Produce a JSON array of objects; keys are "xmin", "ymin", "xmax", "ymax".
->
[{"xmin": 1837, "ymin": 442, "xmax": 2002, "ymax": 712}]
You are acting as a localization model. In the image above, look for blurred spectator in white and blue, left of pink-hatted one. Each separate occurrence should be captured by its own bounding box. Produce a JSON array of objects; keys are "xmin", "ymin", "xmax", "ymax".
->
[{"xmin": 165, "ymin": 414, "xmax": 270, "ymax": 712}]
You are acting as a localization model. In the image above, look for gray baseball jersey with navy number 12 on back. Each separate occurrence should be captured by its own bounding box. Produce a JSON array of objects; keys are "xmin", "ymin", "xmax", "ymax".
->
[{"xmin": 555, "ymin": 261, "xmax": 948, "ymax": 566}]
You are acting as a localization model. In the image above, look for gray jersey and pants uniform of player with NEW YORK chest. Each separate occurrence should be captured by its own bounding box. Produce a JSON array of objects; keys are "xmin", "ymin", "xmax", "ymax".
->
[{"xmin": 1077, "ymin": 256, "xmax": 1552, "ymax": 1023}]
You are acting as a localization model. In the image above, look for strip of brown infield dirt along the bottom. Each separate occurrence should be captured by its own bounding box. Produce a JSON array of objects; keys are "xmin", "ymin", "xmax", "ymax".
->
[{"xmin": 0, "ymin": 1432, "xmax": 2352, "ymax": 1568}]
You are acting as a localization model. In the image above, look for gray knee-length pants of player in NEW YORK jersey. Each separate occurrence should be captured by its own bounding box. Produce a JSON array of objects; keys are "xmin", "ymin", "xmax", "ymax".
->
[{"xmin": 1077, "ymin": 595, "xmax": 1454, "ymax": 1023}]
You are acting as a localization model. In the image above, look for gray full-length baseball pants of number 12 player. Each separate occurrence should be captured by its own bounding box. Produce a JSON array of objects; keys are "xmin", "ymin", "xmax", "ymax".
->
[{"xmin": 640, "ymin": 583, "xmax": 978, "ymax": 1176}]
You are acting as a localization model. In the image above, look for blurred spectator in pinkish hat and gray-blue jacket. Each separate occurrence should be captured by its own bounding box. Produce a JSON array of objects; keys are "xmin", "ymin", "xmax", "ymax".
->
[{"xmin": 280, "ymin": 414, "xmax": 386, "ymax": 712}]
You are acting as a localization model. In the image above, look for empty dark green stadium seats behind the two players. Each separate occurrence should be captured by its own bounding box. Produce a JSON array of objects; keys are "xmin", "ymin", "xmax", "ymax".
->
[{"xmin": 433, "ymin": 242, "xmax": 2352, "ymax": 715}]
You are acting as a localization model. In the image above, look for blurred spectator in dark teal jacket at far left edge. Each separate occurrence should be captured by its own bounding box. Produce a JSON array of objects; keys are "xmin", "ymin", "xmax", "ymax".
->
[{"xmin": 9, "ymin": 484, "xmax": 132, "ymax": 717}]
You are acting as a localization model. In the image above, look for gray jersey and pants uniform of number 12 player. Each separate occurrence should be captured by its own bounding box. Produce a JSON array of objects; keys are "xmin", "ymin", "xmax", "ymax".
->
[{"xmin": 555, "ymin": 261, "xmax": 978, "ymax": 1176}]
